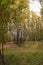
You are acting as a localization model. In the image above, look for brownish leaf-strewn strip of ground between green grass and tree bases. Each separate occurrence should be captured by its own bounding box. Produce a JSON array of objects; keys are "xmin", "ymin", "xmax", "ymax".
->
[{"xmin": 4, "ymin": 41, "xmax": 43, "ymax": 52}]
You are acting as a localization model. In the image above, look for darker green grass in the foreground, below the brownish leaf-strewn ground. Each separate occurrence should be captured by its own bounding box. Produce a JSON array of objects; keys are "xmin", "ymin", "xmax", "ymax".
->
[{"xmin": 5, "ymin": 52, "xmax": 43, "ymax": 65}]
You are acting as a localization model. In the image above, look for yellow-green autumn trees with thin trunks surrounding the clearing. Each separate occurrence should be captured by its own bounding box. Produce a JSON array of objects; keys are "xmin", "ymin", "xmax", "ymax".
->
[{"xmin": 0, "ymin": 0, "xmax": 43, "ymax": 65}]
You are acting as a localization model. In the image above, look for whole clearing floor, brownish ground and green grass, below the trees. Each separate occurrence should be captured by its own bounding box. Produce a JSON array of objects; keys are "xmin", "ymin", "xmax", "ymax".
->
[{"xmin": 0, "ymin": 41, "xmax": 43, "ymax": 65}]
